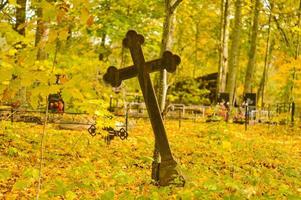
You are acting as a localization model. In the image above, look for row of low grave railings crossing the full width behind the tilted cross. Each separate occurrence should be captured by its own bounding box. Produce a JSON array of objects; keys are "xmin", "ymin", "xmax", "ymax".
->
[{"xmin": 0, "ymin": 102, "xmax": 301, "ymax": 124}]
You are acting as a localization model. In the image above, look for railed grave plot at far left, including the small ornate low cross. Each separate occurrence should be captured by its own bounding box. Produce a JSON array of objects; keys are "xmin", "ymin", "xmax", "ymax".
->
[{"xmin": 0, "ymin": 103, "xmax": 129, "ymax": 144}]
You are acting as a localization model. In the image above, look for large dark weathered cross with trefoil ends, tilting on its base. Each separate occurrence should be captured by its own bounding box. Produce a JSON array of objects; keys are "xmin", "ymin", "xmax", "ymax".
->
[{"xmin": 104, "ymin": 30, "xmax": 184, "ymax": 186}]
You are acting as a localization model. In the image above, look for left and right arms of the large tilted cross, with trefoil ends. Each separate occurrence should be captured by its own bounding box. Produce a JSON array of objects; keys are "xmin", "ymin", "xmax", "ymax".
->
[{"xmin": 103, "ymin": 51, "xmax": 181, "ymax": 87}]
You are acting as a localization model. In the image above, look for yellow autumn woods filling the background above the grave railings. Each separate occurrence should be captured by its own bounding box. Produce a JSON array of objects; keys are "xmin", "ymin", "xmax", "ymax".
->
[{"xmin": 0, "ymin": 0, "xmax": 301, "ymax": 112}]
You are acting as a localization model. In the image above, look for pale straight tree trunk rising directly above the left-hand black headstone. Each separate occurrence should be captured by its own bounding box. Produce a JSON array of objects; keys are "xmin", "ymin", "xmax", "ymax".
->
[{"xmin": 217, "ymin": 0, "xmax": 229, "ymax": 92}]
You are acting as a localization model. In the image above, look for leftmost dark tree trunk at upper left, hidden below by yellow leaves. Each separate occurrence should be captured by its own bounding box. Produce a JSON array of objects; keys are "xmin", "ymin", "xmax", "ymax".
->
[{"xmin": 15, "ymin": 0, "xmax": 26, "ymax": 36}]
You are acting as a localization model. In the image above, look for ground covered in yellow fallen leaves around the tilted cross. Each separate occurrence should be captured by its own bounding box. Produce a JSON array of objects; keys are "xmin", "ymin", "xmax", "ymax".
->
[{"xmin": 0, "ymin": 119, "xmax": 301, "ymax": 199}]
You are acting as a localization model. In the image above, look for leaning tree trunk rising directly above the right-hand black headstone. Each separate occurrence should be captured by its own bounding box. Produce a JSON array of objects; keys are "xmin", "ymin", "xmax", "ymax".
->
[{"xmin": 244, "ymin": 0, "xmax": 260, "ymax": 93}]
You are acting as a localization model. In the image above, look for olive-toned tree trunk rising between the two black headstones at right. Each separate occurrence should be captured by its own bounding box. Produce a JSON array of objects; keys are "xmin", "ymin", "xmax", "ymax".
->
[{"xmin": 226, "ymin": 0, "xmax": 242, "ymax": 105}]
